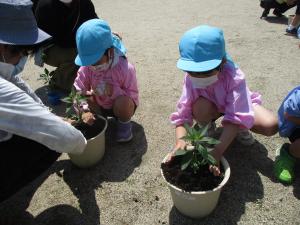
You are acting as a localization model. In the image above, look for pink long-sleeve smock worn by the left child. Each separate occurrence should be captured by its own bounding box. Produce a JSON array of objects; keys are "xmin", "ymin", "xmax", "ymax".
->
[{"xmin": 74, "ymin": 56, "xmax": 139, "ymax": 109}]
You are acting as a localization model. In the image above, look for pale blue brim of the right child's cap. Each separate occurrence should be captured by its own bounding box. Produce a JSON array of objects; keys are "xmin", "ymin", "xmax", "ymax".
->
[{"xmin": 177, "ymin": 59, "xmax": 222, "ymax": 72}]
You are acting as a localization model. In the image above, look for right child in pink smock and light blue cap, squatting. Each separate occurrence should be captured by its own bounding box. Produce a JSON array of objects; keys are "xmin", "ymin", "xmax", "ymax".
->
[{"xmin": 171, "ymin": 25, "xmax": 278, "ymax": 175}]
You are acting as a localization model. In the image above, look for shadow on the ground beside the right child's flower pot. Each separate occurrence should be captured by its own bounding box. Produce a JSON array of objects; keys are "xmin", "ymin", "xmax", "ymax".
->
[{"xmin": 169, "ymin": 138, "xmax": 274, "ymax": 225}]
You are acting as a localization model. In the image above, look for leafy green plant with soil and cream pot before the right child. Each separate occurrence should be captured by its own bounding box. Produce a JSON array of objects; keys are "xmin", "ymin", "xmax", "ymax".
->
[{"xmin": 161, "ymin": 124, "xmax": 230, "ymax": 218}]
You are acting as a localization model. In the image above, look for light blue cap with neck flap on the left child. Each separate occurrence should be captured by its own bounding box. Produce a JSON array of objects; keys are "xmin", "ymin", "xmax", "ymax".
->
[{"xmin": 75, "ymin": 19, "xmax": 126, "ymax": 66}]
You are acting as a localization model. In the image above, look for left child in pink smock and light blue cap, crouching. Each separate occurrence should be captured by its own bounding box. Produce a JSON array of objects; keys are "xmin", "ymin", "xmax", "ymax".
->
[{"xmin": 74, "ymin": 19, "xmax": 139, "ymax": 142}]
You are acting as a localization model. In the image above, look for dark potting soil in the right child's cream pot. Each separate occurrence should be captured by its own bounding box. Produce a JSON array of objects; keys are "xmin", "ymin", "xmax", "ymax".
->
[{"xmin": 161, "ymin": 157, "xmax": 224, "ymax": 192}]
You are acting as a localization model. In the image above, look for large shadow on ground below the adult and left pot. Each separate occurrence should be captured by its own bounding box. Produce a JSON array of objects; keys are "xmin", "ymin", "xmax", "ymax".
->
[{"xmin": 0, "ymin": 119, "xmax": 147, "ymax": 225}]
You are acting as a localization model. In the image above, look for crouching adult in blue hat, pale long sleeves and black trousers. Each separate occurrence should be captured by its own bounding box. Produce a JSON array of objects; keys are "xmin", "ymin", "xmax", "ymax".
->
[{"xmin": 0, "ymin": 0, "xmax": 86, "ymax": 202}]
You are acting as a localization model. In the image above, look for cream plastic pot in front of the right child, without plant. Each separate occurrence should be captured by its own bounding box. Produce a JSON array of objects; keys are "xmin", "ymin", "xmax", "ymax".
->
[{"xmin": 161, "ymin": 157, "xmax": 230, "ymax": 219}]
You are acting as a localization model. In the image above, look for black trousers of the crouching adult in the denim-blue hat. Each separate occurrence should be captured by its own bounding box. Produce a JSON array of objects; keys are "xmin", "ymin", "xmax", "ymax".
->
[{"xmin": 0, "ymin": 135, "xmax": 61, "ymax": 202}]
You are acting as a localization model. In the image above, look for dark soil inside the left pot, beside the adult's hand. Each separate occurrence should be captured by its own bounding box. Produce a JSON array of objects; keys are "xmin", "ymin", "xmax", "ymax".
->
[{"xmin": 74, "ymin": 119, "xmax": 105, "ymax": 140}]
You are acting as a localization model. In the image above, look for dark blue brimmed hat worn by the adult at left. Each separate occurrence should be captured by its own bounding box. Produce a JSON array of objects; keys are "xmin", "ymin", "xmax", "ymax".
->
[{"xmin": 0, "ymin": 0, "xmax": 51, "ymax": 45}]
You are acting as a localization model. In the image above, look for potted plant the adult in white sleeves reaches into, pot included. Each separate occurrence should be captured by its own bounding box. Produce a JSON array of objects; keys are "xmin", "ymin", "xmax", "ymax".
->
[{"xmin": 62, "ymin": 89, "xmax": 107, "ymax": 168}]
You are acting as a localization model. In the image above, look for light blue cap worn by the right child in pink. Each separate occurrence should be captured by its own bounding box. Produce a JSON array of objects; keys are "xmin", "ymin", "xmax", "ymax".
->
[{"xmin": 177, "ymin": 25, "xmax": 226, "ymax": 72}]
